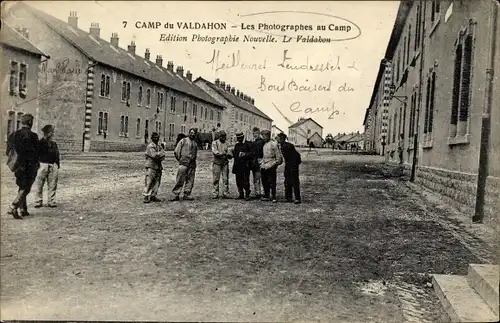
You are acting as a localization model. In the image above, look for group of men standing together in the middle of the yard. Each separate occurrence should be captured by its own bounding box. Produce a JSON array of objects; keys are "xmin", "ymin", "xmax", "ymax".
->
[{"xmin": 143, "ymin": 128, "xmax": 302, "ymax": 204}]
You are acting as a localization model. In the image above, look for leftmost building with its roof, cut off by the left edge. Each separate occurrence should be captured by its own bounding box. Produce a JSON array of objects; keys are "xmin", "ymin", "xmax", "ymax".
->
[{"xmin": 0, "ymin": 23, "xmax": 49, "ymax": 142}]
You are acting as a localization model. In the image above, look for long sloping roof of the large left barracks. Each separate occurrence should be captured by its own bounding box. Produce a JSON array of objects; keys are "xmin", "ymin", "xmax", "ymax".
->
[{"xmin": 16, "ymin": 2, "xmax": 224, "ymax": 108}]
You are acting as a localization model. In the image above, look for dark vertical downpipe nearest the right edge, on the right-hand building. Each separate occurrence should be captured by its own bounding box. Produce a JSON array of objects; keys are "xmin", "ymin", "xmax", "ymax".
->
[{"xmin": 472, "ymin": 0, "xmax": 498, "ymax": 223}]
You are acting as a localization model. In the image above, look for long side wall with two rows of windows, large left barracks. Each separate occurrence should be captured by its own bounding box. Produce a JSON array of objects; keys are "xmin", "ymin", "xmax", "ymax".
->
[{"xmin": 91, "ymin": 66, "xmax": 222, "ymax": 151}]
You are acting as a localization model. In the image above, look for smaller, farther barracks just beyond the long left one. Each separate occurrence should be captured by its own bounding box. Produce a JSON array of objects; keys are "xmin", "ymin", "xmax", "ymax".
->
[{"xmin": 194, "ymin": 77, "xmax": 273, "ymax": 144}]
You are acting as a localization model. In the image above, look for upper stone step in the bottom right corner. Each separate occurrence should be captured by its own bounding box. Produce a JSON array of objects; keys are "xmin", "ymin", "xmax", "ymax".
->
[{"xmin": 467, "ymin": 264, "xmax": 500, "ymax": 315}]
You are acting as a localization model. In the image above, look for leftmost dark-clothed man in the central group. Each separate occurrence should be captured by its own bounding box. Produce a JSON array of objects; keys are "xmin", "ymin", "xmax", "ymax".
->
[{"xmin": 233, "ymin": 132, "xmax": 253, "ymax": 201}]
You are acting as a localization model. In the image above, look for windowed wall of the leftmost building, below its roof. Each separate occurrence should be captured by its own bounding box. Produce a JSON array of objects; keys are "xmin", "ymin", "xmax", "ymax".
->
[{"xmin": 0, "ymin": 46, "xmax": 43, "ymax": 142}]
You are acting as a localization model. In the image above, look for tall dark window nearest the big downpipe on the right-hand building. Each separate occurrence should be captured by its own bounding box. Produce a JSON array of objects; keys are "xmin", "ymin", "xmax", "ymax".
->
[{"xmin": 450, "ymin": 22, "xmax": 474, "ymax": 137}]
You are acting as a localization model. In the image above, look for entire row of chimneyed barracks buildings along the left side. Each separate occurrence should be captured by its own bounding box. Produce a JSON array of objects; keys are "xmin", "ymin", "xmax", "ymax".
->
[{"xmin": 1, "ymin": 2, "xmax": 272, "ymax": 152}]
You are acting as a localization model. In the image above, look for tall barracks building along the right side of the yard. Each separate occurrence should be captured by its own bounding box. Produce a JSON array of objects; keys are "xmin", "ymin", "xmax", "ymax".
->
[{"xmin": 364, "ymin": 0, "xmax": 500, "ymax": 222}]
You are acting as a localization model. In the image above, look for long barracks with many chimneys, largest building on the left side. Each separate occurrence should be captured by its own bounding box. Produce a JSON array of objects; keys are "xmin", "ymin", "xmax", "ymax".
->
[{"xmin": 6, "ymin": 3, "xmax": 223, "ymax": 152}]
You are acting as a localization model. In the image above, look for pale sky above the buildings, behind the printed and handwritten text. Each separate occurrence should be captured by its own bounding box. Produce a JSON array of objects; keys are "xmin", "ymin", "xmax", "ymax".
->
[{"xmin": 20, "ymin": 1, "xmax": 399, "ymax": 135}]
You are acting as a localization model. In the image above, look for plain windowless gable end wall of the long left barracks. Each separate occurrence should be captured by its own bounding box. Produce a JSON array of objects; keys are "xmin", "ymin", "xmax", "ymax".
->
[{"xmin": 5, "ymin": 7, "xmax": 88, "ymax": 152}]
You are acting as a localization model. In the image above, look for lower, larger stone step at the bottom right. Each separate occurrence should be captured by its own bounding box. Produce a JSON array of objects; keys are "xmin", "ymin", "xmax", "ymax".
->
[{"xmin": 432, "ymin": 275, "xmax": 499, "ymax": 322}]
